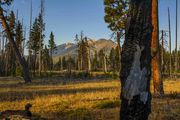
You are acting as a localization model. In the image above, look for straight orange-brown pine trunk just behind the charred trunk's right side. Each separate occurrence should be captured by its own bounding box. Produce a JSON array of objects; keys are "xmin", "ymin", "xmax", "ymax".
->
[{"xmin": 151, "ymin": 0, "xmax": 164, "ymax": 97}]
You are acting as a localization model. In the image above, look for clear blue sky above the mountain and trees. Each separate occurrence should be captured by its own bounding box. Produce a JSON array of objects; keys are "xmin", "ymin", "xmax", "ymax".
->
[{"xmin": 11, "ymin": 0, "xmax": 180, "ymax": 48}]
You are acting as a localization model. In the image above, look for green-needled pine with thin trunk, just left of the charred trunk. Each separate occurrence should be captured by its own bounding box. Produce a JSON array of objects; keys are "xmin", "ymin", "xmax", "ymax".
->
[{"xmin": 104, "ymin": 0, "xmax": 128, "ymax": 71}]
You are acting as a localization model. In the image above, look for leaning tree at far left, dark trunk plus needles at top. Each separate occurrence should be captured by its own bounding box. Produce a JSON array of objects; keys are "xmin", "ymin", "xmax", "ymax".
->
[{"xmin": 0, "ymin": 0, "xmax": 31, "ymax": 83}]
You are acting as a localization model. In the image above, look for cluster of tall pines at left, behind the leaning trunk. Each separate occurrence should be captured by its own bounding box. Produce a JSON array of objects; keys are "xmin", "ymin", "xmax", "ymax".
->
[{"xmin": 0, "ymin": 0, "xmax": 55, "ymax": 79}]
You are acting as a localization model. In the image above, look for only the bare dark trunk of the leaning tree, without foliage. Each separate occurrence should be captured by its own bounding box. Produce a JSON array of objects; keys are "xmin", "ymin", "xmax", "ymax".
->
[{"xmin": 0, "ymin": 7, "xmax": 31, "ymax": 83}]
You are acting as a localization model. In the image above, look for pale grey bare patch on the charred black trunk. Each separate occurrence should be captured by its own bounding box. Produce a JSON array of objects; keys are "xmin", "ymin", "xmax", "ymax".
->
[{"xmin": 123, "ymin": 45, "xmax": 148, "ymax": 104}]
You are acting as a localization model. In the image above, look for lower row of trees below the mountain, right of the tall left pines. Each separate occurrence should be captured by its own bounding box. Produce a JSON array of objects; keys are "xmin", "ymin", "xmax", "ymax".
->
[{"xmin": 53, "ymin": 35, "xmax": 120, "ymax": 73}]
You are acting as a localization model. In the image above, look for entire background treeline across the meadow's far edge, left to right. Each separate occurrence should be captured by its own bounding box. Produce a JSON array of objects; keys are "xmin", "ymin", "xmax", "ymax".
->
[{"xmin": 0, "ymin": 10, "xmax": 180, "ymax": 77}]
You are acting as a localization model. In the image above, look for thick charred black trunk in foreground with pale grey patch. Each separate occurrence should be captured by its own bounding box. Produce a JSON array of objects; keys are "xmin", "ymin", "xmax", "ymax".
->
[{"xmin": 120, "ymin": 0, "xmax": 152, "ymax": 120}]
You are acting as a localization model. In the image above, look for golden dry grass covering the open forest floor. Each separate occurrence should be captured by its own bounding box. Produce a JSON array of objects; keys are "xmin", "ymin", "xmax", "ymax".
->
[{"xmin": 0, "ymin": 79, "xmax": 180, "ymax": 120}]
